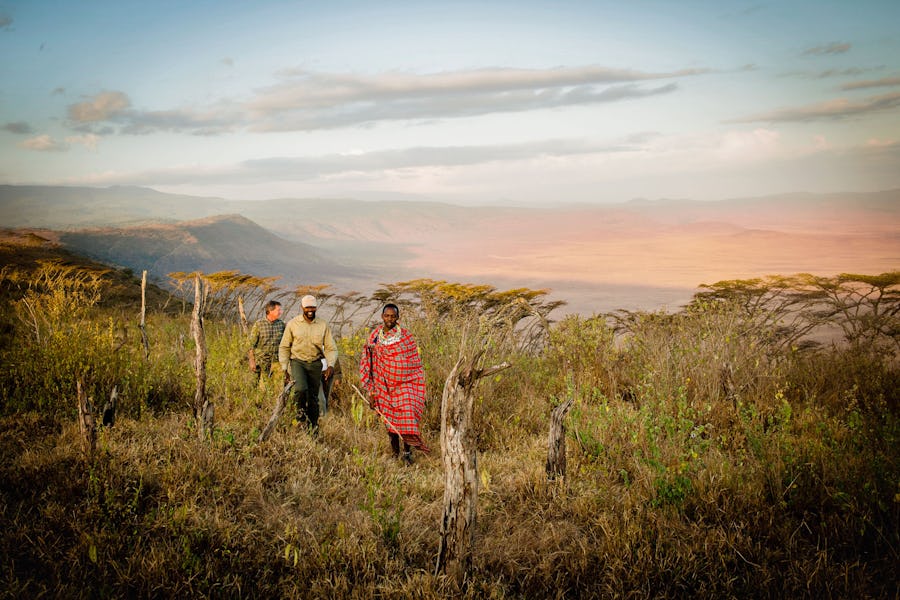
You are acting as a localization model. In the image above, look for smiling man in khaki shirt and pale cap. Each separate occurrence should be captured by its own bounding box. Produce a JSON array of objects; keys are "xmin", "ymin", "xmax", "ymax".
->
[{"xmin": 278, "ymin": 296, "xmax": 337, "ymax": 434}]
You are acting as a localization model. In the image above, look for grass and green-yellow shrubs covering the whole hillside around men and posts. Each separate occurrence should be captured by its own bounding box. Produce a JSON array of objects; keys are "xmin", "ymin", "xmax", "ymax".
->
[{"xmin": 0, "ymin": 276, "xmax": 900, "ymax": 598}]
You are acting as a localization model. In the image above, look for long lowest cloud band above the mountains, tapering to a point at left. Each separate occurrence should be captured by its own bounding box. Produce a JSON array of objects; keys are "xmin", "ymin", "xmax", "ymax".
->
[{"xmin": 59, "ymin": 127, "xmax": 900, "ymax": 203}]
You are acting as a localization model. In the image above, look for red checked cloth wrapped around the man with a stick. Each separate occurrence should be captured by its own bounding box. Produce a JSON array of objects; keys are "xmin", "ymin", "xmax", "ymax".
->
[{"xmin": 359, "ymin": 325, "xmax": 428, "ymax": 452}]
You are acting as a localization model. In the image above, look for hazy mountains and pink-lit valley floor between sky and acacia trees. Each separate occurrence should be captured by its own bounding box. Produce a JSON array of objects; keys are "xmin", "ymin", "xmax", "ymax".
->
[{"xmin": 0, "ymin": 186, "xmax": 900, "ymax": 313}]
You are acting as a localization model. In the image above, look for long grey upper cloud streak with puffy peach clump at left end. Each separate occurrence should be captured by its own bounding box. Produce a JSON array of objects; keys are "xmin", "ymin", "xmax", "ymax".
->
[{"xmin": 61, "ymin": 67, "xmax": 708, "ymax": 135}]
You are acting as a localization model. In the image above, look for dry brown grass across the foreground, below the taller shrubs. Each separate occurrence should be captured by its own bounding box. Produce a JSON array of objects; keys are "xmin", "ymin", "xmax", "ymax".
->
[{"xmin": 0, "ymin": 342, "xmax": 897, "ymax": 598}]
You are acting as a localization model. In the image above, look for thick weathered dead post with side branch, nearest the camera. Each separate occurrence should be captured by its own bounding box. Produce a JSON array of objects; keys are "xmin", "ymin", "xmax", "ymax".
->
[{"xmin": 435, "ymin": 352, "xmax": 509, "ymax": 586}]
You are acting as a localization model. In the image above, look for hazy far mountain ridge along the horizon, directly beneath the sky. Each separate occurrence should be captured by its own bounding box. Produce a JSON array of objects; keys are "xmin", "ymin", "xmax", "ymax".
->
[{"xmin": 0, "ymin": 185, "xmax": 900, "ymax": 236}]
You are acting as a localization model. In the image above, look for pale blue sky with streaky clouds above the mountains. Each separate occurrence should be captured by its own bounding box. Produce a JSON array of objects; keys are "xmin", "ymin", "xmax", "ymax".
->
[{"xmin": 0, "ymin": 0, "xmax": 900, "ymax": 205}]
